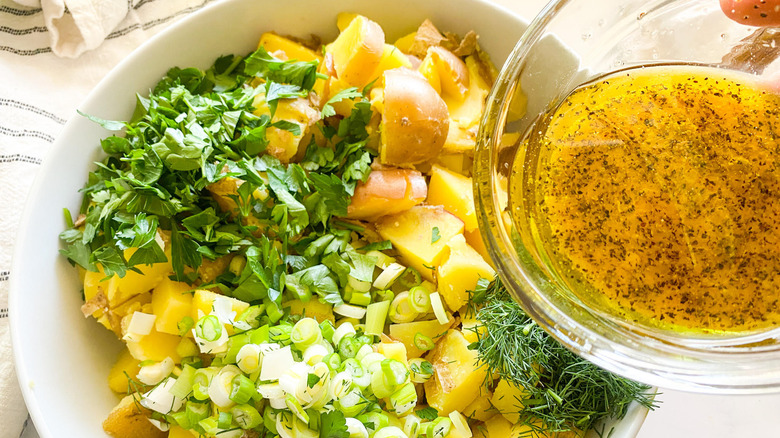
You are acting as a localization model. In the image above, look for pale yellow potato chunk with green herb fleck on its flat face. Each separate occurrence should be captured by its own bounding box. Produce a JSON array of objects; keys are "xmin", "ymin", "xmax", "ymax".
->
[{"xmin": 376, "ymin": 205, "xmax": 463, "ymax": 281}]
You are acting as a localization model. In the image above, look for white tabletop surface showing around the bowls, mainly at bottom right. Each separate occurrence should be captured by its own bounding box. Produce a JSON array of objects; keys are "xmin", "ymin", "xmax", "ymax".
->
[{"xmin": 16, "ymin": 0, "xmax": 780, "ymax": 438}]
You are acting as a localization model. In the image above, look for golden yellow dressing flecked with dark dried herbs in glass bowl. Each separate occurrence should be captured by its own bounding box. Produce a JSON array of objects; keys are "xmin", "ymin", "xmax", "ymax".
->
[{"xmin": 510, "ymin": 65, "xmax": 780, "ymax": 334}]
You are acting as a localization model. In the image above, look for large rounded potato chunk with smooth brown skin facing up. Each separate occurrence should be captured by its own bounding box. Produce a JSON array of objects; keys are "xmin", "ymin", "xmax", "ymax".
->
[{"xmin": 379, "ymin": 68, "xmax": 449, "ymax": 166}]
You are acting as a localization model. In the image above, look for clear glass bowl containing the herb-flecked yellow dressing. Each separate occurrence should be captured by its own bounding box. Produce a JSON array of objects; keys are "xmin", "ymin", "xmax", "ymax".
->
[{"xmin": 474, "ymin": 0, "xmax": 780, "ymax": 394}]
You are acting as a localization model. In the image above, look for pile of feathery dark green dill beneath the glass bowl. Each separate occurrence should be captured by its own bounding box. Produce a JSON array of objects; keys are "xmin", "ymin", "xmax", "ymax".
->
[{"xmin": 471, "ymin": 279, "xmax": 655, "ymax": 431}]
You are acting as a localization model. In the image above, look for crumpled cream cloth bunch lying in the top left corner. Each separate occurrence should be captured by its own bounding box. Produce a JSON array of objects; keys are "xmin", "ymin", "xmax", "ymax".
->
[{"xmin": 16, "ymin": 0, "xmax": 131, "ymax": 58}]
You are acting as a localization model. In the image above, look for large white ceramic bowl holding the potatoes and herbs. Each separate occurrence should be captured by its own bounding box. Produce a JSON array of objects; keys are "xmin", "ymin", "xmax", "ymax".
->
[{"xmin": 10, "ymin": 0, "xmax": 646, "ymax": 438}]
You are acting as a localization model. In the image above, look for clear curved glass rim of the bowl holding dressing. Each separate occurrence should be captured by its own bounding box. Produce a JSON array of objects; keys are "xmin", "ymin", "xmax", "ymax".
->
[{"xmin": 474, "ymin": 0, "xmax": 780, "ymax": 394}]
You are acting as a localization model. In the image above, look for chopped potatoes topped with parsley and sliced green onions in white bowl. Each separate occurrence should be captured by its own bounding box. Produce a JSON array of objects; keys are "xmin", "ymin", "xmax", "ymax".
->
[{"xmin": 61, "ymin": 13, "xmax": 652, "ymax": 438}]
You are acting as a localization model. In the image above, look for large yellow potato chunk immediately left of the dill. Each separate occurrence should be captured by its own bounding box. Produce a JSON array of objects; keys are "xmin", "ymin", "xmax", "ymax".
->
[{"xmin": 424, "ymin": 330, "xmax": 487, "ymax": 412}]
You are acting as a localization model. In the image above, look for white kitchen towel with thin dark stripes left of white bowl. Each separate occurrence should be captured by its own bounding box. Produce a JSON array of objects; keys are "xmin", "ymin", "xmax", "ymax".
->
[{"xmin": 0, "ymin": 0, "xmax": 215, "ymax": 438}]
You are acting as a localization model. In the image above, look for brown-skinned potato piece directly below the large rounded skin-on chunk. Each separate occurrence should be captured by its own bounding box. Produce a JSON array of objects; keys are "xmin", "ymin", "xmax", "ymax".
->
[{"xmin": 347, "ymin": 169, "xmax": 428, "ymax": 220}]
